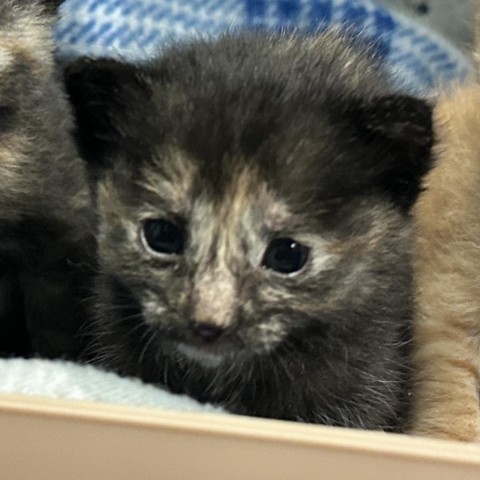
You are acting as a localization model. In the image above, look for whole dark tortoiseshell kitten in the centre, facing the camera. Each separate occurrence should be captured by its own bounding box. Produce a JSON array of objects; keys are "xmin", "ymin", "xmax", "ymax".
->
[{"xmin": 66, "ymin": 31, "xmax": 431, "ymax": 429}]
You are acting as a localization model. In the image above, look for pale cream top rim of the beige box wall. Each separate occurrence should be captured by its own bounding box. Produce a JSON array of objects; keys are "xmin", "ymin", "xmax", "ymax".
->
[{"xmin": 0, "ymin": 394, "xmax": 480, "ymax": 466}]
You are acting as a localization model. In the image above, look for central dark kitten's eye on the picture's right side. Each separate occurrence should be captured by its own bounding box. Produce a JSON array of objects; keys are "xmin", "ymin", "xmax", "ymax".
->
[{"xmin": 262, "ymin": 238, "xmax": 310, "ymax": 274}]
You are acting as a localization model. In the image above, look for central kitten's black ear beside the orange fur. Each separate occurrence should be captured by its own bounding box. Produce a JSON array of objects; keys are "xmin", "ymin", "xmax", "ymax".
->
[{"xmin": 356, "ymin": 94, "xmax": 433, "ymax": 209}]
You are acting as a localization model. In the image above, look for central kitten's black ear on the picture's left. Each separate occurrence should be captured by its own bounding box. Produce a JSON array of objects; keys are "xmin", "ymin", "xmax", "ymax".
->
[{"xmin": 64, "ymin": 58, "xmax": 140, "ymax": 169}]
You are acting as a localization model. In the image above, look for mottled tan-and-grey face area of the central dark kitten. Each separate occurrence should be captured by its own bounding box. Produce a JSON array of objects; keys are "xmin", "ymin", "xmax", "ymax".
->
[{"xmin": 98, "ymin": 152, "xmax": 408, "ymax": 365}]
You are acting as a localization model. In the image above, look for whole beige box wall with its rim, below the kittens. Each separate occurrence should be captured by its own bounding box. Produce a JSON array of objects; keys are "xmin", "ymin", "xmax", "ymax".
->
[{"xmin": 0, "ymin": 395, "xmax": 480, "ymax": 480}]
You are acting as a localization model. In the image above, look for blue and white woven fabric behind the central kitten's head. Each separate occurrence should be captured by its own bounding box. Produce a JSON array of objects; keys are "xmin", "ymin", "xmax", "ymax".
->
[{"xmin": 56, "ymin": 0, "xmax": 470, "ymax": 91}]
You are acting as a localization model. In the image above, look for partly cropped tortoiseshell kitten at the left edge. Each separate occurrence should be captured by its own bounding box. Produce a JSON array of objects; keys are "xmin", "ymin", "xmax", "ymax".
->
[{"xmin": 0, "ymin": 0, "xmax": 93, "ymax": 356}]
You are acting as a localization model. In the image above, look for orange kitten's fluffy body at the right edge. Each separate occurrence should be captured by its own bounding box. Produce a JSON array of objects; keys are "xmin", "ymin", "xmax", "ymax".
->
[{"xmin": 411, "ymin": 85, "xmax": 480, "ymax": 441}]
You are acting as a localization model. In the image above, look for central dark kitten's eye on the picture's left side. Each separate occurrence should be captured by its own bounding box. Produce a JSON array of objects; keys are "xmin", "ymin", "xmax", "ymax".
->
[{"xmin": 143, "ymin": 220, "xmax": 185, "ymax": 255}]
